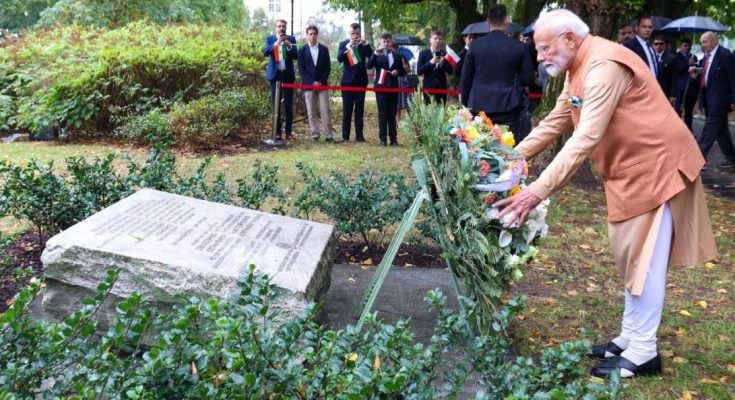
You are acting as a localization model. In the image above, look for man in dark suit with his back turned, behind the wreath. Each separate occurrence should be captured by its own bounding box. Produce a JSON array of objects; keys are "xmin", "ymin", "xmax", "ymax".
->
[{"xmin": 460, "ymin": 4, "xmax": 533, "ymax": 138}]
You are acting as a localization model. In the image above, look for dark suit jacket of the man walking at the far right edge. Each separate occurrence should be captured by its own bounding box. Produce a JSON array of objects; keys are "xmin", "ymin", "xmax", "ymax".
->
[{"xmin": 699, "ymin": 46, "xmax": 735, "ymax": 116}]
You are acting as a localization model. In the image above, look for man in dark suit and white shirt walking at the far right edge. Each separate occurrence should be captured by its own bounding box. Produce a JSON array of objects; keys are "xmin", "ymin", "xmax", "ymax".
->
[{"xmin": 690, "ymin": 32, "xmax": 735, "ymax": 169}]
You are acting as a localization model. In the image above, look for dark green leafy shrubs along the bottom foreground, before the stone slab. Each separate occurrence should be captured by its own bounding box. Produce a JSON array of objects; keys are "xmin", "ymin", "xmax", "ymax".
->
[{"xmin": 0, "ymin": 267, "xmax": 620, "ymax": 399}]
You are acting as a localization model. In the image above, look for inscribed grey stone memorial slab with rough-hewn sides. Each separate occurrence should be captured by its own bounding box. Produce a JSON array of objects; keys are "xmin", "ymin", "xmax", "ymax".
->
[{"xmin": 41, "ymin": 189, "xmax": 335, "ymax": 319}]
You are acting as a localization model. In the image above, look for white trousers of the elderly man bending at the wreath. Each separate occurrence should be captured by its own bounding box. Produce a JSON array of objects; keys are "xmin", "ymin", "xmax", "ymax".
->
[{"xmin": 620, "ymin": 203, "xmax": 674, "ymax": 365}]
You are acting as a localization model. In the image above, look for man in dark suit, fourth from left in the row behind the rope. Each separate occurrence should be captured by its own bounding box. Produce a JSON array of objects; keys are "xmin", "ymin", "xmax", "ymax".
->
[{"xmin": 367, "ymin": 32, "xmax": 406, "ymax": 146}]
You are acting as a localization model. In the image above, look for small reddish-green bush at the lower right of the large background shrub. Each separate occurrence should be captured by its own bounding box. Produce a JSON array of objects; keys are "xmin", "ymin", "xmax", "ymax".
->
[{"xmin": 169, "ymin": 89, "xmax": 269, "ymax": 148}]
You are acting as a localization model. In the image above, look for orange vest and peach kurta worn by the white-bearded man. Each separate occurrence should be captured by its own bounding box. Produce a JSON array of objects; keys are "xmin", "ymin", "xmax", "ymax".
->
[{"xmin": 516, "ymin": 35, "xmax": 716, "ymax": 294}]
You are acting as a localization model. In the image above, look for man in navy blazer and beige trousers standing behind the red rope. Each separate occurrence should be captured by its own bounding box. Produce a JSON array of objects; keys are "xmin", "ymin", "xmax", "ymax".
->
[{"xmin": 298, "ymin": 25, "xmax": 334, "ymax": 142}]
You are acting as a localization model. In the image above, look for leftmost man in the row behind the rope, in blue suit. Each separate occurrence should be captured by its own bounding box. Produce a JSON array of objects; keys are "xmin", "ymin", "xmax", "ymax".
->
[{"xmin": 263, "ymin": 19, "xmax": 298, "ymax": 140}]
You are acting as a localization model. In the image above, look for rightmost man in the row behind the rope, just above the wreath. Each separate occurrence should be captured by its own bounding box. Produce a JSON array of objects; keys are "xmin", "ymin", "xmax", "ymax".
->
[{"xmin": 416, "ymin": 30, "xmax": 452, "ymax": 104}]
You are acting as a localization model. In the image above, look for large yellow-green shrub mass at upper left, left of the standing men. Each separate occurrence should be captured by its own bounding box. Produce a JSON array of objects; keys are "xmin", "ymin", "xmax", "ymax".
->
[{"xmin": 0, "ymin": 22, "xmax": 267, "ymax": 131}]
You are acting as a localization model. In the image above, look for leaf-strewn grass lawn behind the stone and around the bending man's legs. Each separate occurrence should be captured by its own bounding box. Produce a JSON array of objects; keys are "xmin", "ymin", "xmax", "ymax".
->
[{"xmin": 0, "ymin": 113, "xmax": 735, "ymax": 399}]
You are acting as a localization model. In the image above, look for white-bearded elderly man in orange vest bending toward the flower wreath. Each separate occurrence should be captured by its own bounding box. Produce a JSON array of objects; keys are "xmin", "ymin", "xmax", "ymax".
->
[{"xmin": 495, "ymin": 10, "xmax": 716, "ymax": 377}]
